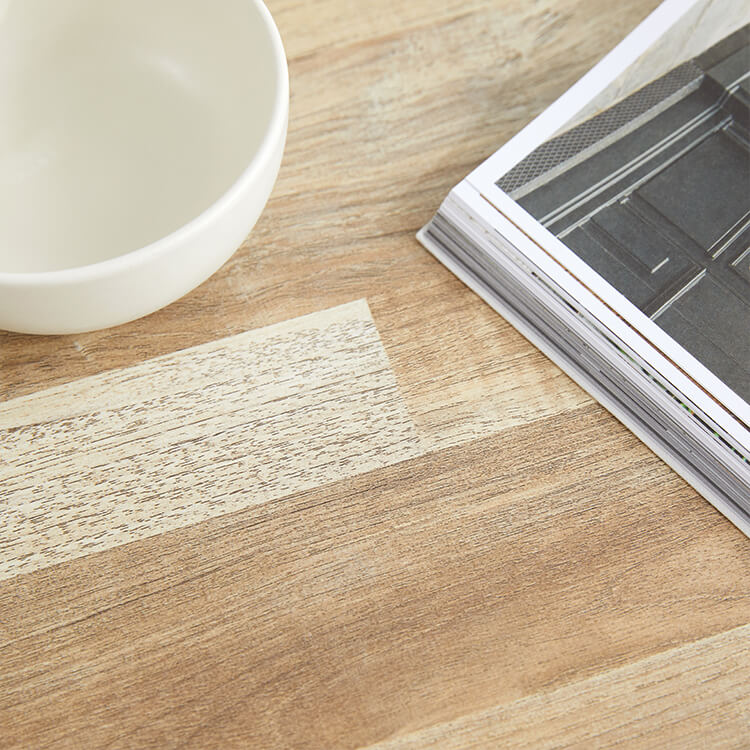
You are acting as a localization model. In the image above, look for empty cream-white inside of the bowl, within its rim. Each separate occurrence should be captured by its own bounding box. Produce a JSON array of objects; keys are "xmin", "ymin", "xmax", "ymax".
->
[{"xmin": 0, "ymin": 0, "xmax": 280, "ymax": 273}]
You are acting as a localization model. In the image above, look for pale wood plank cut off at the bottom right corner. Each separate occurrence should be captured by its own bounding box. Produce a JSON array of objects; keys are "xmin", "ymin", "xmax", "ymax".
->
[{"xmin": 369, "ymin": 625, "xmax": 750, "ymax": 750}]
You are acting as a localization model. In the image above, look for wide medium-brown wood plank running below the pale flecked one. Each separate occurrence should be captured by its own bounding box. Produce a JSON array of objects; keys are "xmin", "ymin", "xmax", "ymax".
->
[{"xmin": 0, "ymin": 405, "xmax": 750, "ymax": 748}]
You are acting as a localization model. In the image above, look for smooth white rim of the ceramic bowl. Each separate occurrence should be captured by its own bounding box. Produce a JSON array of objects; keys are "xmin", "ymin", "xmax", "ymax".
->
[{"xmin": 0, "ymin": 0, "xmax": 289, "ymax": 289}]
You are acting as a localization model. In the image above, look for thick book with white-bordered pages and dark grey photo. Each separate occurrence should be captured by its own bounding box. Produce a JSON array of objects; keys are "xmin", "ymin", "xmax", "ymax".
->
[{"xmin": 419, "ymin": 0, "xmax": 750, "ymax": 535}]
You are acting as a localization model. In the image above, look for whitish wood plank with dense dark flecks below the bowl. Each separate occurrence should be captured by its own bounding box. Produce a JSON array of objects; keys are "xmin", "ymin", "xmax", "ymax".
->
[{"xmin": 0, "ymin": 301, "xmax": 419, "ymax": 579}]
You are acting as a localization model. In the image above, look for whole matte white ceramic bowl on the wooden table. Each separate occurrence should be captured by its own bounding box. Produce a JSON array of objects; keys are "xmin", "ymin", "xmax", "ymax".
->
[{"xmin": 0, "ymin": 0, "xmax": 289, "ymax": 333}]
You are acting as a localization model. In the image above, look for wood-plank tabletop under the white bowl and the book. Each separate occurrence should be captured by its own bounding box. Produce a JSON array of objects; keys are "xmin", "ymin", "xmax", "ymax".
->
[{"xmin": 0, "ymin": 0, "xmax": 750, "ymax": 748}]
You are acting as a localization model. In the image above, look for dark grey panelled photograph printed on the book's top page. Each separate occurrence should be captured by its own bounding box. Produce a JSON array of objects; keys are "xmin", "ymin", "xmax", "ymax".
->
[{"xmin": 506, "ymin": 26, "xmax": 750, "ymax": 403}]
